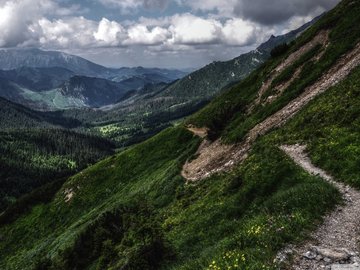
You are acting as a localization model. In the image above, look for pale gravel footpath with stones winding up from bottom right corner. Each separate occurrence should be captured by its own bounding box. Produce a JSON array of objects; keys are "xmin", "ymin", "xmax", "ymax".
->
[{"xmin": 278, "ymin": 145, "xmax": 360, "ymax": 270}]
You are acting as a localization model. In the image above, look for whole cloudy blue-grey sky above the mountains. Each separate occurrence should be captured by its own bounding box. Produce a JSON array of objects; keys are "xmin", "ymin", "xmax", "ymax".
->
[{"xmin": 0, "ymin": 0, "xmax": 340, "ymax": 69}]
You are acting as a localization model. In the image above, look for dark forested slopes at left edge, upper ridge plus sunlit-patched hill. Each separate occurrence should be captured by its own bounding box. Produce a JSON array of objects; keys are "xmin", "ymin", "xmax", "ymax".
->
[{"xmin": 0, "ymin": 98, "xmax": 115, "ymax": 212}]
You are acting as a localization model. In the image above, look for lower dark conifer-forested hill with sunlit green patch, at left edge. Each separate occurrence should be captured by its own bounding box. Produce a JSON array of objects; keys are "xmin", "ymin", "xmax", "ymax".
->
[{"xmin": 0, "ymin": 128, "xmax": 114, "ymax": 211}]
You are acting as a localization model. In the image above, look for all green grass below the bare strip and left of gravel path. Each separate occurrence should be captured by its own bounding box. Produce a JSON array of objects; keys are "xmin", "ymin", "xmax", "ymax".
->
[{"xmin": 0, "ymin": 127, "xmax": 339, "ymax": 269}]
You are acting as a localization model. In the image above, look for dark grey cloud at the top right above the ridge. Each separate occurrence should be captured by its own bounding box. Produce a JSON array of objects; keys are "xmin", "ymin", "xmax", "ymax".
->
[{"xmin": 234, "ymin": 0, "xmax": 340, "ymax": 25}]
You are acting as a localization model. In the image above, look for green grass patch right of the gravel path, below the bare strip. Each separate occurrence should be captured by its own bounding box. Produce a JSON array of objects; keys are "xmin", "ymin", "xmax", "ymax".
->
[{"xmin": 269, "ymin": 65, "xmax": 360, "ymax": 188}]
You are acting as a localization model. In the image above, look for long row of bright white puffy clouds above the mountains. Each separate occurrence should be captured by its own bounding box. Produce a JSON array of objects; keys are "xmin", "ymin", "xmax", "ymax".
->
[{"xmin": 27, "ymin": 13, "xmax": 261, "ymax": 50}]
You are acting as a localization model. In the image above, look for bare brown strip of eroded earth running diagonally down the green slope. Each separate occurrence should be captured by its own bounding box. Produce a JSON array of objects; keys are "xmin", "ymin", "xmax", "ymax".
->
[{"xmin": 181, "ymin": 43, "xmax": 360, "ymax": 181}]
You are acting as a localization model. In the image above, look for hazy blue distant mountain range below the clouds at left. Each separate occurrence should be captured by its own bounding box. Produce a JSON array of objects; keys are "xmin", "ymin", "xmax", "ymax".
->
[{"xmin": 0, "ymin": 49, "xmax": 187, "ymax": 110}]
